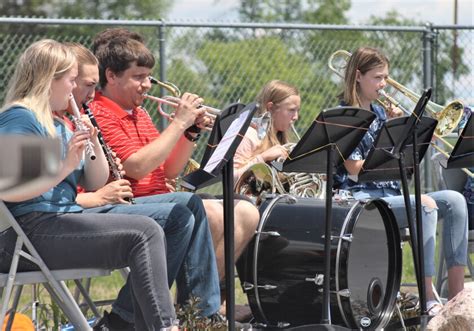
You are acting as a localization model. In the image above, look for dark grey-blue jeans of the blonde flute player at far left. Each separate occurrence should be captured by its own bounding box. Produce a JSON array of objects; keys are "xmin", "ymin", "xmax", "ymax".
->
[{"xmin": 0, "ymin": 212, "xmax": 176, "ymax": 330}]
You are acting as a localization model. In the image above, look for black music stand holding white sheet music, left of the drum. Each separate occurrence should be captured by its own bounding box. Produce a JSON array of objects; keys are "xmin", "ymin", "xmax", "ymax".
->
[{"xmin": 181, "ymin": 102, "xmax": 258, "ymax": 331}]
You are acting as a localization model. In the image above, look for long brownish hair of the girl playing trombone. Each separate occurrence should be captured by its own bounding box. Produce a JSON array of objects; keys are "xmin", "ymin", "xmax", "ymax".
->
[{"xmin": 340, "ymin": 47, "xmax": 390, "ymax": 107}]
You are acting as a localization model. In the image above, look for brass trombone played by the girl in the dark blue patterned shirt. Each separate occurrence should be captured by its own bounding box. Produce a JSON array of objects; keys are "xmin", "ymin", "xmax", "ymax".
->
[{"xmin": 328, "ymin": 49, "xmax": 474, "ymax": 177}]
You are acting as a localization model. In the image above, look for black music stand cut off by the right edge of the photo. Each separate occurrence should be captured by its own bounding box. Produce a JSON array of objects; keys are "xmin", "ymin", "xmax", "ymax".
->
[{"xmin": 440, "ymin": 114, "xmax": 474, "ymax": 169}]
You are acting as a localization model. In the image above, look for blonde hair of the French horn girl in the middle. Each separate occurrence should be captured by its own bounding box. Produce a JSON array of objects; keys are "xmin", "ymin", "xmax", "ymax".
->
[{"xmin": 256, "ymin": 80, "xmax": 300, "ymax": 152}]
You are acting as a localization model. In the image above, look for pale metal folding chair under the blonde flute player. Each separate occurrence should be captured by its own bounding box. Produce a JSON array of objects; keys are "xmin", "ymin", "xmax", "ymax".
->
[{"xmin": 0, "ymin": 200, "xmax": 111, "ymax": 330}]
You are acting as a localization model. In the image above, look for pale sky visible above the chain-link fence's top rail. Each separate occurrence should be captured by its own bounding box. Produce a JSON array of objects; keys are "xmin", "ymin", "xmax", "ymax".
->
[{"xmin": 167, "ymin": 0, "xmax": 474, "ymax": 25}]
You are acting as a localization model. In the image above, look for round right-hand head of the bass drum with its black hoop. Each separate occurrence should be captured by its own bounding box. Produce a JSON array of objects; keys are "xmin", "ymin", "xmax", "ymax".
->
[{"xmin": 336, "ymin": 200, "xmax": 402, "ymax": 329}]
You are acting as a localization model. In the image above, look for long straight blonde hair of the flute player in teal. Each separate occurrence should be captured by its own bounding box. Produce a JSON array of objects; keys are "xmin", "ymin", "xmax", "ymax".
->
[{"xmin": 0, "ymin": 39, "xmax": 76, "ymax": 136}]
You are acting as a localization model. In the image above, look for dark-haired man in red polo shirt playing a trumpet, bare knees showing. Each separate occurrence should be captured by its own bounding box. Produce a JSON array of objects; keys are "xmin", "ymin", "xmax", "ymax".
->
[{"xmin": 90, "ymin": 33, "xmax": 259, "ymax": 320}]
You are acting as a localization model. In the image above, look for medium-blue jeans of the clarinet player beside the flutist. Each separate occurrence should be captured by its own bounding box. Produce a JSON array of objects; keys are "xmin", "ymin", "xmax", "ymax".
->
[{"xmin": 86, "ymin": 192, "xmax": 220, "ymax": 322}]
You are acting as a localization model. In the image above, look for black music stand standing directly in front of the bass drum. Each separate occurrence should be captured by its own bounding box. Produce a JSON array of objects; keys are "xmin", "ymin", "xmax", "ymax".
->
[{"xmin": 272, "ymin": 107, "xmax": 375, "ymax": 330}]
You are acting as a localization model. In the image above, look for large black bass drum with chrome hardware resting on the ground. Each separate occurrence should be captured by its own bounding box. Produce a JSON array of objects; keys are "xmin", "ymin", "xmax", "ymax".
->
[{"xmin": 237, "ymin": 195, "xmax": 402, "ymax": 329}]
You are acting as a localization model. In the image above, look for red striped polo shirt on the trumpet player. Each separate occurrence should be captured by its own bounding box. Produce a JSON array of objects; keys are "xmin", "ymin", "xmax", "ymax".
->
[{"xmin": 89, "ymin": 92, "xmax": 169, "ymax": 197}]
